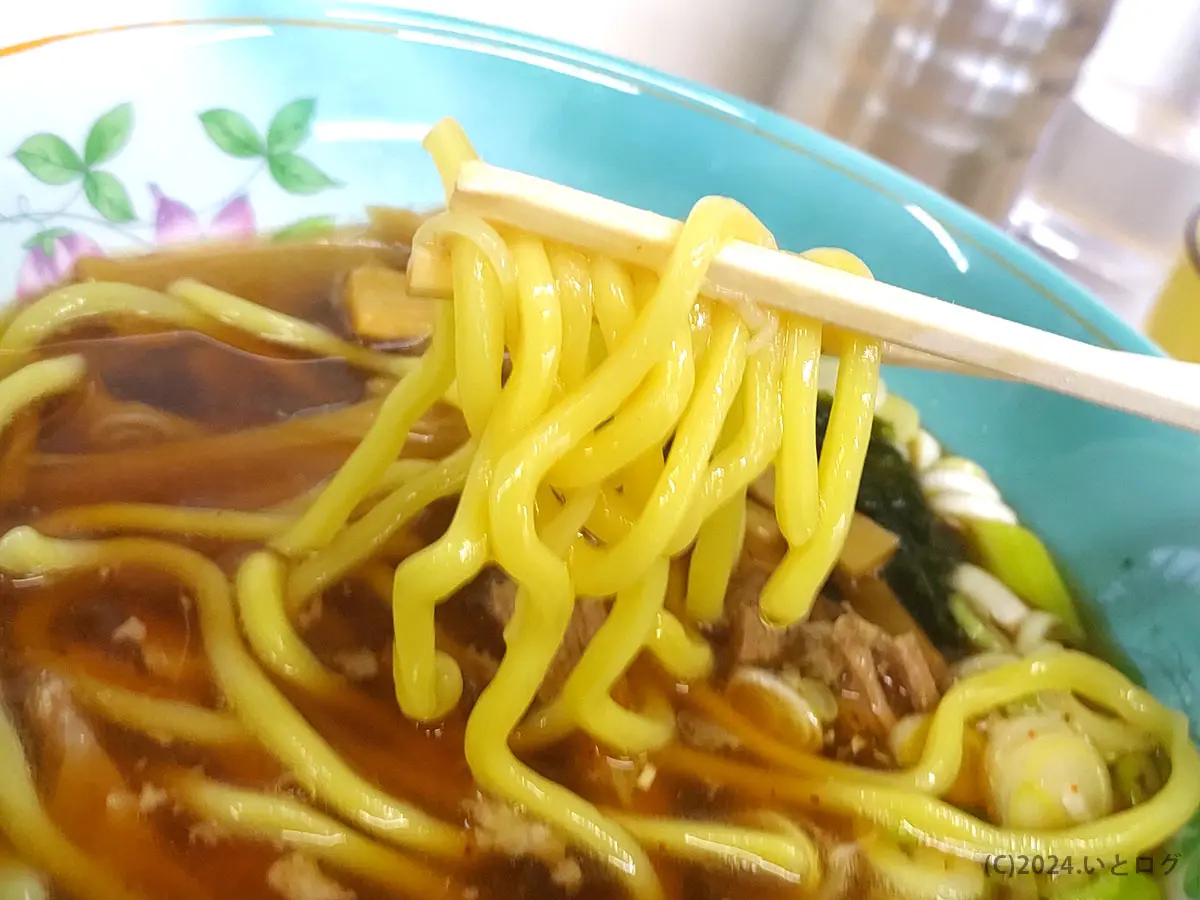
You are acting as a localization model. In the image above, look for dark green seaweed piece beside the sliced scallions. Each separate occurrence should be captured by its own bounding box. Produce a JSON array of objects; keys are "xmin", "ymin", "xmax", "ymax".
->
[{"xmin": 817, "ymin": 394, "xmax": 967, "ymax": 654}]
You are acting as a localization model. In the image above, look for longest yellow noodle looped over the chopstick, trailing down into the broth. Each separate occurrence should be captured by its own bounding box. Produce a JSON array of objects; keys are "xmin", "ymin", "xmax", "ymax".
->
[{"xmin": 475, "ymin": 211, "xmax": 758, "ymax": 873}]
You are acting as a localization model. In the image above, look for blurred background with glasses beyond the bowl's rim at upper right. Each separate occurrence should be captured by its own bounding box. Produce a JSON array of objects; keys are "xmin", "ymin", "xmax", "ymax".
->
[{"xmin": 395, "ymin": 0, "xmax": 1200, "ymax": 355}]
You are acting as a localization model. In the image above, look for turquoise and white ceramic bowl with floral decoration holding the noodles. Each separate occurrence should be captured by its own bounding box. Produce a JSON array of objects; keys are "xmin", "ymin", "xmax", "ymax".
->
[{"xmin": 7, "ymin": 0, "xmax": 1200, "ymax": 888}]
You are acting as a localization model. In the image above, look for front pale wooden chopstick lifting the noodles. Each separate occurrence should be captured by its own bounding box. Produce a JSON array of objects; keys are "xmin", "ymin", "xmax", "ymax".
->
[{"xmin": 436, "ymin": 161, "xmax": 1200, "ymax": 432}]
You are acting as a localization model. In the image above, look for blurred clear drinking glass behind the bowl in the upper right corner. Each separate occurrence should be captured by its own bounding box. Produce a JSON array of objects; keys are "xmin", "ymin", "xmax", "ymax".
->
[{"xmin": 1008, "ymin": 0, "xmax": 1200, "ymax": 324}]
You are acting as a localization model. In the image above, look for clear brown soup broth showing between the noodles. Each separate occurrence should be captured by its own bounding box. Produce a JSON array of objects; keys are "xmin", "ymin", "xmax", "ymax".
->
[{"xmin": 0, "ymin": 245, "xmax": 931, "ymax": 900}]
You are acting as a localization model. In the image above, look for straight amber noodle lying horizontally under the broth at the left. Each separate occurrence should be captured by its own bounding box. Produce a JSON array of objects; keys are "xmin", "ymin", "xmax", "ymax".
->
[{"xmin": 37, "ymin": 503, "xmax": 293, "ymax": 541}]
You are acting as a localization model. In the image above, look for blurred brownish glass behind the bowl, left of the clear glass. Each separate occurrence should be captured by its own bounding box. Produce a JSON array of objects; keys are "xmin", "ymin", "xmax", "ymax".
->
[{"xmin": 773, "ymin": 0, "xmax": 1113, "ymax": 222}]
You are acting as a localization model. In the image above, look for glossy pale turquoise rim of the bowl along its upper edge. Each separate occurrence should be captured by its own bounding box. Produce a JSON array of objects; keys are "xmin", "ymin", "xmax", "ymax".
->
[{"xmin": 0, "ymin": 0, "xmax": 1163, "ymax": 355}]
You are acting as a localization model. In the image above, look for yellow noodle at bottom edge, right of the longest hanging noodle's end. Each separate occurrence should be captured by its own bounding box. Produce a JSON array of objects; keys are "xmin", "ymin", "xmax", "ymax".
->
[{"xmin": 612, "ymin": 811, "xmax": 821, "ymax": 889}]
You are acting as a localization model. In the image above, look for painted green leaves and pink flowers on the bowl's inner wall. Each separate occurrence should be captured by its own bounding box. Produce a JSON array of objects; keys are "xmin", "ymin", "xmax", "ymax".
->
[{"xmin": 9, "ymin": 97, "xmax": 341, "ymax": 296}]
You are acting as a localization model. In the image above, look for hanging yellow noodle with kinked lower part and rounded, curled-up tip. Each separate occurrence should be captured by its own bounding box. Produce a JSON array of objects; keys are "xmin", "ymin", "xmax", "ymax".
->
[{"xmin": 394, "ymin": 238, "xmax": 562, "ymax": 721}]
